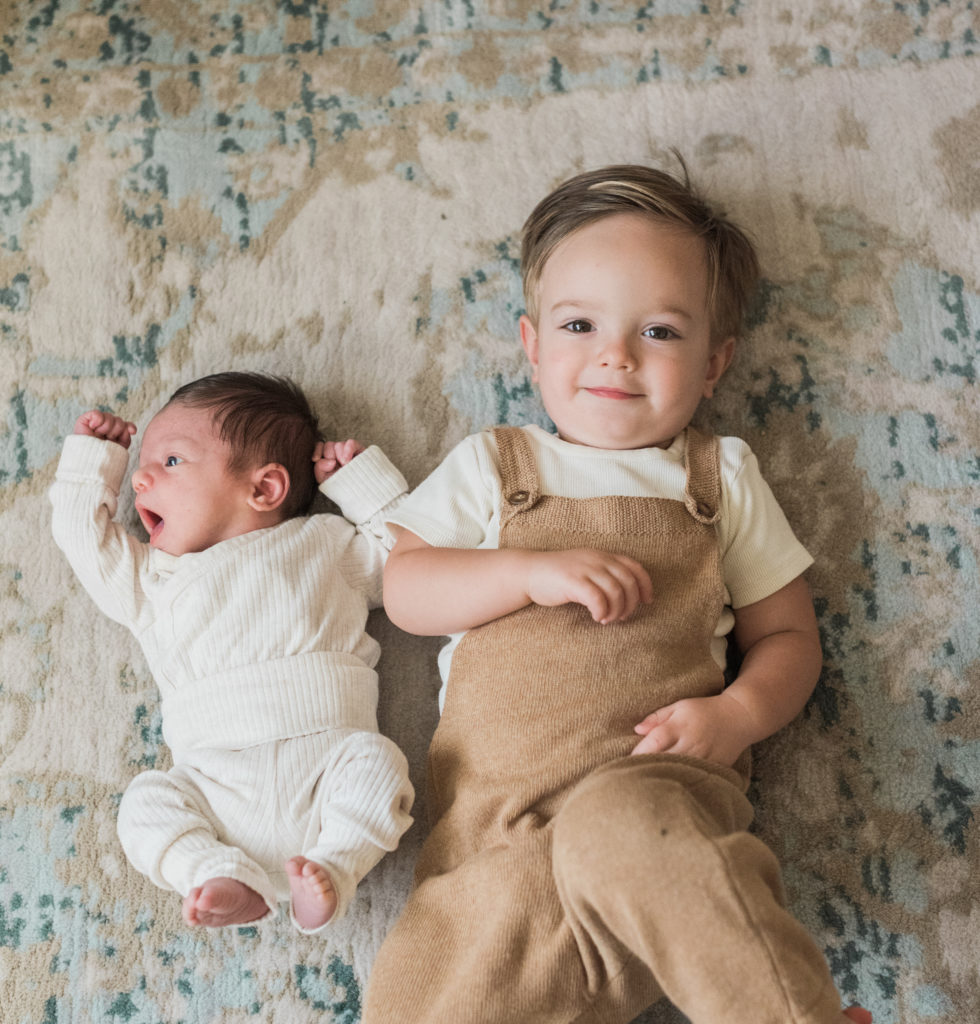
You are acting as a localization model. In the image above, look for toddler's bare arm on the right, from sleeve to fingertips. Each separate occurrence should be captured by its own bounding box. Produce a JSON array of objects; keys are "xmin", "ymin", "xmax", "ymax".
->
[{"xmin": 633, "ymin": 577, "xmax": 822, "ymax": 765}]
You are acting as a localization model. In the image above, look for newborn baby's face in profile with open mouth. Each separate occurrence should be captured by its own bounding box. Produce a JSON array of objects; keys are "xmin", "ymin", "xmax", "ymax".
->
[{"xmin": 132, "ymin": 403, "xmax": 260, "ymax": 555}]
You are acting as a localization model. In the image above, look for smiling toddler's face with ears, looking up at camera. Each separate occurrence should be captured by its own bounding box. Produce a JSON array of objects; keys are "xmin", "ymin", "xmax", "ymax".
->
[{"xmin": 521, "ymin": 213, "xmax": 734, "ymax": 449}]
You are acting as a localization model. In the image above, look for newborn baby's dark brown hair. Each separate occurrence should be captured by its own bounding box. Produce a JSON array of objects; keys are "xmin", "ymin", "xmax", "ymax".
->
[{"xmin": 167, "ymin": 371, "xmax": 319, "ymax": 519}]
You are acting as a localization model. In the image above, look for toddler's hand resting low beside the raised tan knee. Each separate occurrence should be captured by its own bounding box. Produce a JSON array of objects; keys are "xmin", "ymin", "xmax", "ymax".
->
[{"xmin": 630, "ymin": 693, "xmax": 754, "ymax": 768}]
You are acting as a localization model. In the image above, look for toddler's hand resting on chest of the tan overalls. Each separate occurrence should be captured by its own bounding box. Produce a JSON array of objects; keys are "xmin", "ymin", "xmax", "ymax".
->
[{"xmin": 527, "ymin": 548, "xmax": 653, "ymax": 626}]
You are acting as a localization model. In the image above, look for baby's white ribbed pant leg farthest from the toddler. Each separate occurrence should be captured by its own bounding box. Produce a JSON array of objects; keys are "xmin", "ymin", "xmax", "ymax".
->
[{"xmin": 117, "ymin": 766, "xmax": 278, "ymax": 911}]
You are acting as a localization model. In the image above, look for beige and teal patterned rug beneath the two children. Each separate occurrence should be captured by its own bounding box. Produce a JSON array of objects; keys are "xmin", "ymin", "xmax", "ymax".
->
[{"xmin": 0, "ymin": 0, "xmax": 980, "ymax": 1024}]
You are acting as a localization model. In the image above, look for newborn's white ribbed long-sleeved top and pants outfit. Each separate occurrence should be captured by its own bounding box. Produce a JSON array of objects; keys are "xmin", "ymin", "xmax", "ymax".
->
[{"xmin": 50, "ymin": 435, "xmax": 414, "ymax": 923}]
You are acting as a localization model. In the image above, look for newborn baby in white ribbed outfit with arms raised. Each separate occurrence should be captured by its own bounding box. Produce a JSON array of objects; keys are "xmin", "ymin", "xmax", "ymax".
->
[{"xmin": 50, "ymin": 373, "xmax": 414, "ymax": 932}]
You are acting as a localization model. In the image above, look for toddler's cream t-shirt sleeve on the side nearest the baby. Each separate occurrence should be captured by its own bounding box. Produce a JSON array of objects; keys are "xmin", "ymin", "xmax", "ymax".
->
[{"xmin": 387, "ymin": 432, "xmax": 500, "ymax": 548}]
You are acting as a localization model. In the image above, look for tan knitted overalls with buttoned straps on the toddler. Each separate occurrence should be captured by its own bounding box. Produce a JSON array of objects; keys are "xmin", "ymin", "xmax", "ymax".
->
[{"xmin": 363, "ymin": 428, "xmax": 840, "ymax": 1024}]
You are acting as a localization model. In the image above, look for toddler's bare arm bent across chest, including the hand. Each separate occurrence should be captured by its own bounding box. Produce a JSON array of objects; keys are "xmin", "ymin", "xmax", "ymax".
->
[{"xmin": 384, "ymin": 526, "xmax": 652, "ymax": 636}]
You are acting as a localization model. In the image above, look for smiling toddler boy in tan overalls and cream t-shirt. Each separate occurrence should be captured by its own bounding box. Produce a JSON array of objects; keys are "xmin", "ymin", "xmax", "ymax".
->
[{"xmin": 364, "ymin": 166, "xmax": 868, "ymax": 1024}]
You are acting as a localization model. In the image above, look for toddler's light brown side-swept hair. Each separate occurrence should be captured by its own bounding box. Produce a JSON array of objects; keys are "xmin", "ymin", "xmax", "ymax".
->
[{"xmin": 521, "ymin": 157, "xmax": 759, "ymax": 344}]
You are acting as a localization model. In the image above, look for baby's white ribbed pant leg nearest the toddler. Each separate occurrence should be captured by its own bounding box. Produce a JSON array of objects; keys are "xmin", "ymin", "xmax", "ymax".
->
[{"xmin": 294, "ymin": 732, "xmax": 415, "ymax": 921}]
